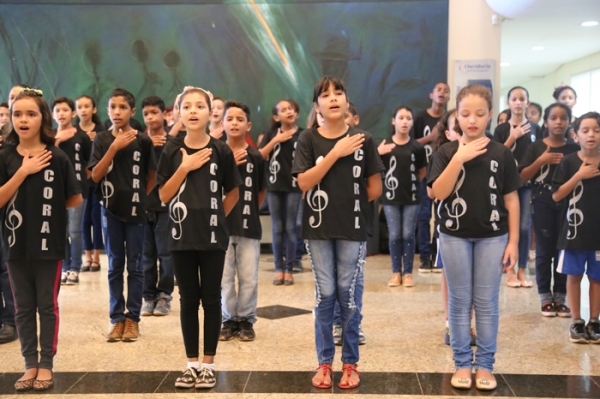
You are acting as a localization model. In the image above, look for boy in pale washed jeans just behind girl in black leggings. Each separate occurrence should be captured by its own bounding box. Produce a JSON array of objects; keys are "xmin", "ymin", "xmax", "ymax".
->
[{"xmin": 219, "ymin": 101, "xmax": 267, "ymax": 341}]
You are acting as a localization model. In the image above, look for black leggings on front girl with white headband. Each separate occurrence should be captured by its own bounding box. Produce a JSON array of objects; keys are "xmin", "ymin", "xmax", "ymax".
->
[{"xmin": 171, "ymin": 251, "xmax": 225, "ymax": 358}]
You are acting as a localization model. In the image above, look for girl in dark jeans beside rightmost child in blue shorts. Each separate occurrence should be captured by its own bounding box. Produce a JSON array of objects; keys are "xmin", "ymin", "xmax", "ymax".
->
[{"xmin": 521, "ymin": 103, "xmax": 579, "ymax": 317}]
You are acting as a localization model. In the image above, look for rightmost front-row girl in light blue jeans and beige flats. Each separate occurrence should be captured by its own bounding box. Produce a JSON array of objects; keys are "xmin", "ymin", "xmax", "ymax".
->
[{"xmin": 428, "ymin": 85, "xmax": 521, "ymax": 390}]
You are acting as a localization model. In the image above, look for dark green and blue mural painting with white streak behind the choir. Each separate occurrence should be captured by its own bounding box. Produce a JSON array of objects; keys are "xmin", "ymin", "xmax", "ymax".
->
[{"xmin": 0, "ymin": 0, "xmax": 448, "ymax": 136}]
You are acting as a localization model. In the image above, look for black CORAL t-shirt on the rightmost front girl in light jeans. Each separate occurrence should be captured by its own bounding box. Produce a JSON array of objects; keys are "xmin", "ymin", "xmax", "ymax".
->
[{"xmin": 427, "ymin": 141, "xmax": 521, "ymax": 238}]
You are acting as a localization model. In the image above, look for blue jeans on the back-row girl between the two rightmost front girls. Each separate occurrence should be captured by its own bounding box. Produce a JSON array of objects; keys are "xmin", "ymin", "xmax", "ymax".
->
[{"xmin": 383, "ymin": 204, "xmax": 419, "ymax": 275}]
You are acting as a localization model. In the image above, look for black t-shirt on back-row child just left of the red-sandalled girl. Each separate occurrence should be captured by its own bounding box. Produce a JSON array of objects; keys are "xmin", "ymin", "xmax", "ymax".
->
[{"xmin": 258, "ymin": 128, "xmax": 303, "ymax": 193}]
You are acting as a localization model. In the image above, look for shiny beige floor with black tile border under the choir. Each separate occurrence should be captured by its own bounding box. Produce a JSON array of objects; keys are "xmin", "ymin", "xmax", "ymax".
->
[{"xmin": 0, "ymin": 255, "xmax": 600, "ymax": 399}]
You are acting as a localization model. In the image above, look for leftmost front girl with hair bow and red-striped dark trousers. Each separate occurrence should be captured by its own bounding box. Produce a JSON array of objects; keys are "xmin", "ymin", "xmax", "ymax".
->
[{"xmin": 0, "ymin": 89, "xmax": 83, "ymax": 391}]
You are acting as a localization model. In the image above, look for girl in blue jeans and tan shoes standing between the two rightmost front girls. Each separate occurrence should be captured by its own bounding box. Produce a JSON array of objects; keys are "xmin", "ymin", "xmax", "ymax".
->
[{"xmin": 377, "ymin": 105, "xmax": 427, "ymax": 287}]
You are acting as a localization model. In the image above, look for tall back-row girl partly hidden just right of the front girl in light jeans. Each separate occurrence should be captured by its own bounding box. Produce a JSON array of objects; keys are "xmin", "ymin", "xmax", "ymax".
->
[{"xmin": 494, "ymin": 86, "xmax": 542, "ymax": 288}]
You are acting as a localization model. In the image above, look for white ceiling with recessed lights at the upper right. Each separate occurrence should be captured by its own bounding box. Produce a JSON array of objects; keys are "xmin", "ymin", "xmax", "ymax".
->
[{"xmin": 496, "ymin": 0, "xmax": 600, "ymax": 87}]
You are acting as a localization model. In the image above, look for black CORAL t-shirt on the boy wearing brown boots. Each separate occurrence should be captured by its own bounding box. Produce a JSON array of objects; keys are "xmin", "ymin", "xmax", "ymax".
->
[{"xmin": 88, "ymin": 131, "xmax": 156, "ymax": 223}]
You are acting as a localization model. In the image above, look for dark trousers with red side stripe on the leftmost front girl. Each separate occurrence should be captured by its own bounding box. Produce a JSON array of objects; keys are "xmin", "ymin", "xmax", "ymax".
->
[{"xmin": 7, "ymin": 259, "xmax": 62, "ymax": 370}]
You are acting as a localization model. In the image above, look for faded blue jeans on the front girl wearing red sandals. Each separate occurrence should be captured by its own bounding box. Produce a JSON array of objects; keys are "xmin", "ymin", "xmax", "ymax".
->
[{"xmin": 306, "ymin": 240, "xmax": 367, "ymax": 364}]
